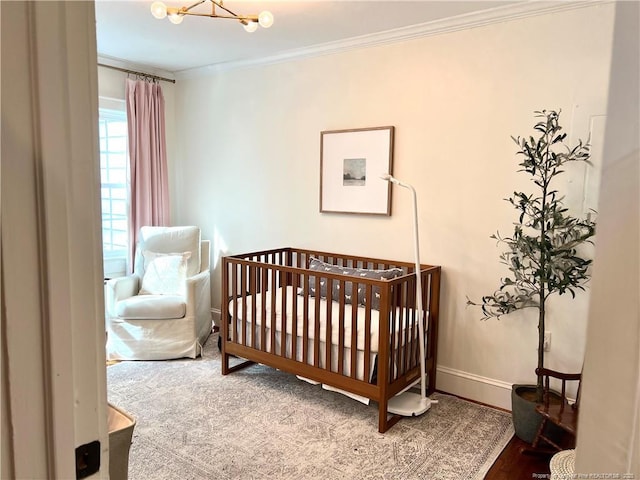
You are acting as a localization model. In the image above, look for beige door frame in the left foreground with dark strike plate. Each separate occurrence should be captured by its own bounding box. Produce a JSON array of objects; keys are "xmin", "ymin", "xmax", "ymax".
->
[{"xmin": 0, "ymin": 1, "xmax": 109, "ymax": 478}]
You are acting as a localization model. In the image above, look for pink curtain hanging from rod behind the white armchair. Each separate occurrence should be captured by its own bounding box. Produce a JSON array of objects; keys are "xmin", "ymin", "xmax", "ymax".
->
[{"xmin": 126, "ymin": 78, "xmax": 170, "ymax": 266}]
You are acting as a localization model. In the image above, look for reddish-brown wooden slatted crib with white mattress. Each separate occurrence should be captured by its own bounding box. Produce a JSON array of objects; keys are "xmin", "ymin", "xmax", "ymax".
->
[{"xmin": 221, "ymin": 248, "xmax": 440, "ymax": 433}]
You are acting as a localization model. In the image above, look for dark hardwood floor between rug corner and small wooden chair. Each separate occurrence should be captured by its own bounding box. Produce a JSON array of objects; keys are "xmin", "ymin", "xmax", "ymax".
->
[{"xmin": 484, "ymin": 436, "xmax": 551, "ymax": 480}]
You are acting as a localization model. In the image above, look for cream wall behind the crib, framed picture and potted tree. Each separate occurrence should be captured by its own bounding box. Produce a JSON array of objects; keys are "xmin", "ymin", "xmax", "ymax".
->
[{"xmin": 171, "ymin": 4, "xmax": 614, "ymax": 408}]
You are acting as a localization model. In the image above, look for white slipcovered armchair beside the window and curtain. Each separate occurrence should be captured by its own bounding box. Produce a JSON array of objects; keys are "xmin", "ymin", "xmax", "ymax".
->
[{"xmin": 105, "ymin": 226, "xmax": 212, "ymax": 360}]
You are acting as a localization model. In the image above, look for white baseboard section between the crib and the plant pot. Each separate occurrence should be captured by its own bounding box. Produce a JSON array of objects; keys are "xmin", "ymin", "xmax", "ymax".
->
[{"xmin": 436, "ymin": 366, "xmax": 511, "ymax": 410}]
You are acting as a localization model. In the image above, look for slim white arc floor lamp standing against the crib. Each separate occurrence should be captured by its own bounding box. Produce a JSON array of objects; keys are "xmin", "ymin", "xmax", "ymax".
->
[{"xmin": 380, "ymin": 173, "xmax": 437, "ymax": 417}]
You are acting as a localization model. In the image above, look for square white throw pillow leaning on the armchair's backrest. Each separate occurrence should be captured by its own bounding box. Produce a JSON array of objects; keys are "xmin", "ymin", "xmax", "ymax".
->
[{"xmin": 139, "ymin": 250, "xmax": 191, "ymax": 295}]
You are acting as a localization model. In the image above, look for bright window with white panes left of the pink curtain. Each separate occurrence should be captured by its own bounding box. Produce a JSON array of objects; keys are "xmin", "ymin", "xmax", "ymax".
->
[{"xmin": 99, "ymin": 108, "xmax": 129, "ymax": 277}]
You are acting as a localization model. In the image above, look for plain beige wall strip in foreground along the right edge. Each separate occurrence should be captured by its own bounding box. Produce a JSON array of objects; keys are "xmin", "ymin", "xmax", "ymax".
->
[{"xmin": 576, "ymin": 2, "xmax": 640, "ymax": 478}]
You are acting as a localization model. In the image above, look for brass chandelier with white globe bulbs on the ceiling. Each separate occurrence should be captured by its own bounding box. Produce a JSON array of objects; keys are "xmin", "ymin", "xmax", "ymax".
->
[{"xmin": 151, "ymin": 0, "xmax": 273, "ymax": 32}]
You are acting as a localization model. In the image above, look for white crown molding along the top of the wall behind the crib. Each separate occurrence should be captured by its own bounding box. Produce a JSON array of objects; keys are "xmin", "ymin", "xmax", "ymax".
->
[{"xmin": 174, "ymin": 0, "xmax": 613, "ymax": 80}]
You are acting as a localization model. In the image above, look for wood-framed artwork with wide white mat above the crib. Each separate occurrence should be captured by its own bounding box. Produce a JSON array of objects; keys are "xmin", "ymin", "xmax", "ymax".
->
[{"xmin": 320, "ymin": 127, "xmax": 394, "ymax": 216}]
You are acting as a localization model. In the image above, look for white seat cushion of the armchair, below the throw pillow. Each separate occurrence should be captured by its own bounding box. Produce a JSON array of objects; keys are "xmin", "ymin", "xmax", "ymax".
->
[{"xmin": 116, "ymin": 295, "xmax": 187, "ymax": 320}]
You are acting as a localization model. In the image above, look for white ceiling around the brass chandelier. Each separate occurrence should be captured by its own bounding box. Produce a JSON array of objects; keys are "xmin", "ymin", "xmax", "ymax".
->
[{"xmin": 95, "ymin": 0, "xmax": 532, "ymax": 74}]
